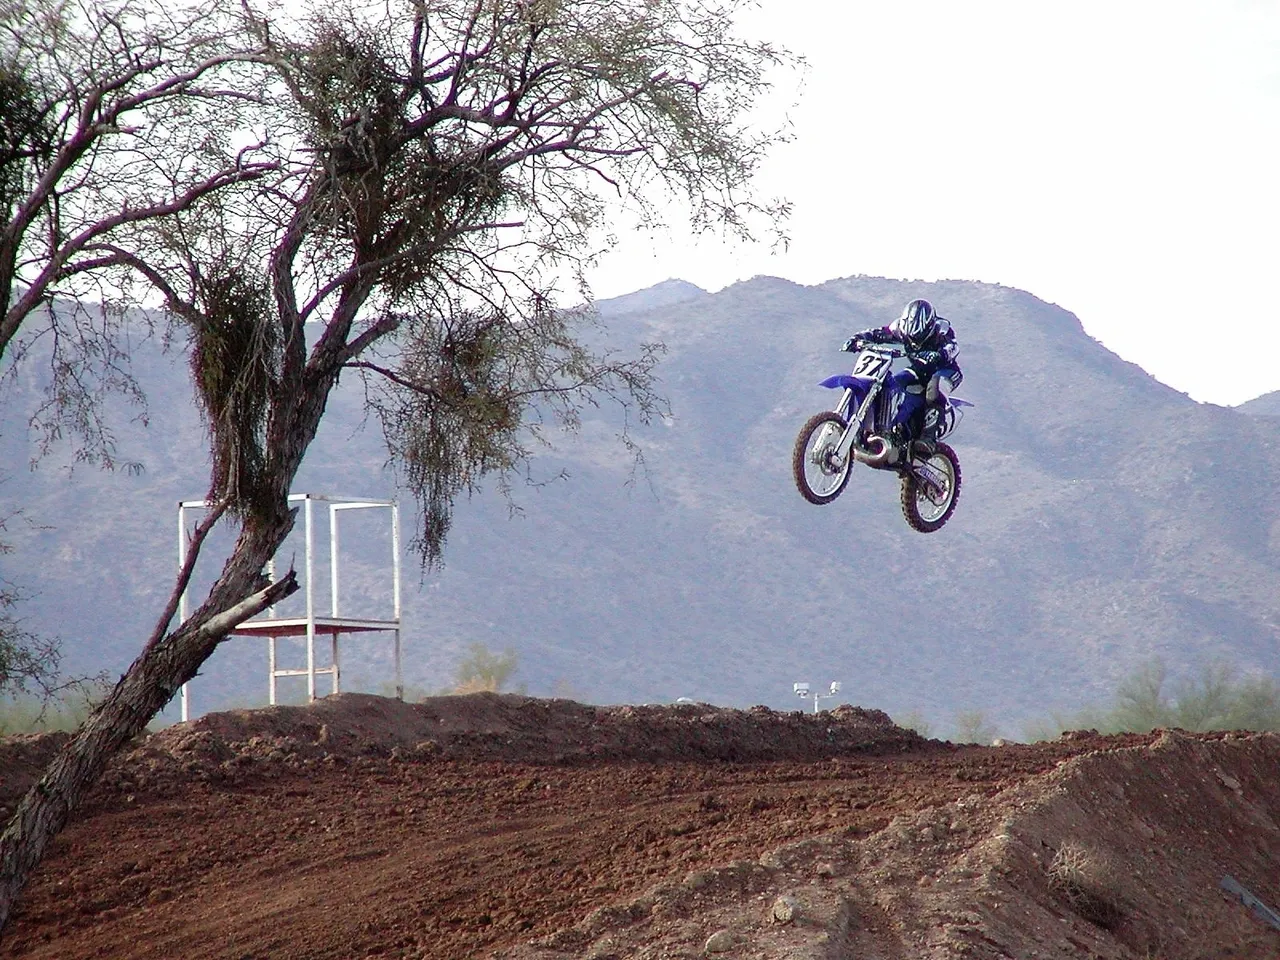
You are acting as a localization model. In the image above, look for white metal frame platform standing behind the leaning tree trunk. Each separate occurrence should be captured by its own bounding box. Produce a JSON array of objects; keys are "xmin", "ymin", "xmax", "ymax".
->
[{"xmin": 178, "ymin": 493, "xmax": 404, "ymax": 721}]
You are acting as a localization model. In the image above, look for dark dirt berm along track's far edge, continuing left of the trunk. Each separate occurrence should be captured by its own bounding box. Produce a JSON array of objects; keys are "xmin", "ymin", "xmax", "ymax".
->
[{"xmin": 0, "ymin": 692, "xmax": 927, "ymax": 818}]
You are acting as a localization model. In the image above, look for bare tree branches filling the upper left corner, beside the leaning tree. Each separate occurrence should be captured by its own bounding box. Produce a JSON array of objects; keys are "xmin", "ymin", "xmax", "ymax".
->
[{"xmin": 0, "ymin": 0, "xmax": 271, "ymax": 466}]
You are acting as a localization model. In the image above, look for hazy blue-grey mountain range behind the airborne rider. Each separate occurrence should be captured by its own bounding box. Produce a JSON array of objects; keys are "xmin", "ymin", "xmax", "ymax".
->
[{"xmin": 0, "ymin": 276, "xmax": 1280, "ymax": 735}]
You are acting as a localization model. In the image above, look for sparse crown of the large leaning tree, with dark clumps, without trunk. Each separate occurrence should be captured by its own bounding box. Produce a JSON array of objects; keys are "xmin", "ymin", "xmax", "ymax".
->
[{"xmin": 226, "ymin": 0, "xmax": 790, "ymax": 564}]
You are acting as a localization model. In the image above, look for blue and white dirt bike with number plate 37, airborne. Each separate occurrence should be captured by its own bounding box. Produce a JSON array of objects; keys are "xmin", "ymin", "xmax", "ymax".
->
[{"xmin": 791, "ymin": 343, "xmax": 973, "ymax": 534}]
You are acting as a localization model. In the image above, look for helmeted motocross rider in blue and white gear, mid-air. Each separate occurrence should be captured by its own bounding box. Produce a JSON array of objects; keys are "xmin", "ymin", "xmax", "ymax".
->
[{"xmin": 844, "ymin": 298, "xmax": 964, "ymax": 444}]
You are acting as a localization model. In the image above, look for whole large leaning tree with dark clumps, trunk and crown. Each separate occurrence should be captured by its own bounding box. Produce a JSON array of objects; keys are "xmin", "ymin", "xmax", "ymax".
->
[{"xmin": 0, "ymin": 0, "xmax": 785, "ymax": 924}]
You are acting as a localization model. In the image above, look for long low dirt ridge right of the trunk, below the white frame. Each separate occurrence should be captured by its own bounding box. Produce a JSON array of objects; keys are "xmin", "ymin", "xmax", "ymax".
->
[{"xmin": 151, "ymin": 694, "xmax": 925, "ymax": 764}]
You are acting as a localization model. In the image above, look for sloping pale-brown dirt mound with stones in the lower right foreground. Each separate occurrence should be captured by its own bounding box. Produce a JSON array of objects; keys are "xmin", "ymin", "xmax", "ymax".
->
[{"xmin": 498, "ymin": 732, "xmax": 1280, "ymax": 960}]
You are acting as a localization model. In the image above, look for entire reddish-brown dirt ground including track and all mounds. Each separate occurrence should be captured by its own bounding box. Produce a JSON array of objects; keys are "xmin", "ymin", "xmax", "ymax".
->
[{"xmin": 0, "ymin": 694, "xmax": 1280, "ymax": 960}]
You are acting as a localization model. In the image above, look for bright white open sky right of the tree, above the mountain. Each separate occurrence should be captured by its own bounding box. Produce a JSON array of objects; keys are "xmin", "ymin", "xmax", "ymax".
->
[{"xmin": 590, "ymin": 0, "xmax": 1280, "ymax": 404}]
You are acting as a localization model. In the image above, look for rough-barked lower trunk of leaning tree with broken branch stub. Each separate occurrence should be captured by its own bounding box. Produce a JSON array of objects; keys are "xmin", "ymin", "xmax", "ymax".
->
[{"xmin": 0, "ymin": 555, "xmax": 298, "ymax": 933}]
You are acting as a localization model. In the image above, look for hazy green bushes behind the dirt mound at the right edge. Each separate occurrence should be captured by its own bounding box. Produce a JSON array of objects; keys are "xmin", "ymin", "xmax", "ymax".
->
[{"xmin": 1027, "ymin": 659, "xmax": 1280, "ymax": 740}]
